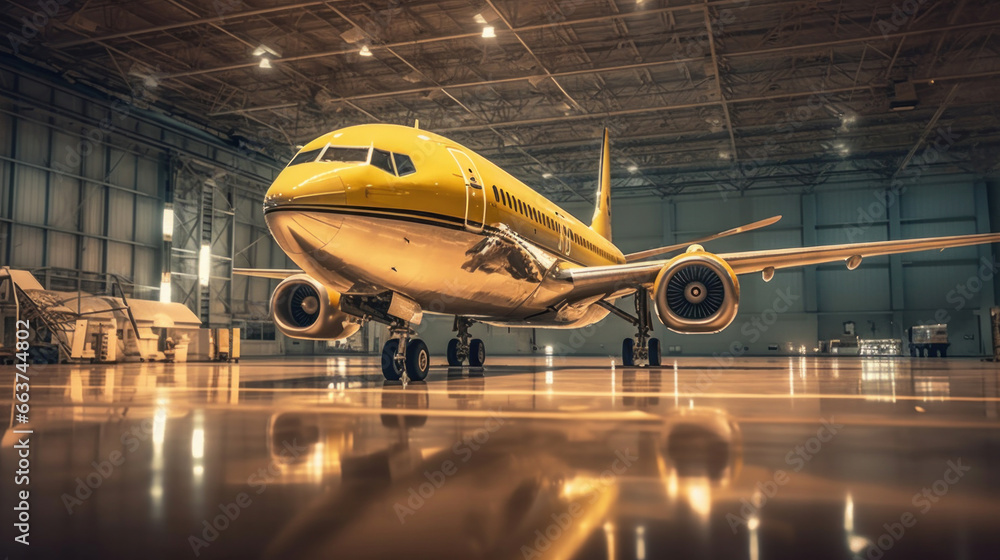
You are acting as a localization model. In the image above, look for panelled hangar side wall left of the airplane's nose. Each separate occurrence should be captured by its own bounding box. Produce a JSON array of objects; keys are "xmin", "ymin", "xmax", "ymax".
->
[{"xmin": 0, "ymin": 58, "xmax": 289, "ymax": 354}]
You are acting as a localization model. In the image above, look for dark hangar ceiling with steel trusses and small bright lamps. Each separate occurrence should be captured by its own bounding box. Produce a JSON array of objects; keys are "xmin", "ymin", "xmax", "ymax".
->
[{"xmin": 0, "ymin": 0, "xmax": 1000, "ymax": 200}]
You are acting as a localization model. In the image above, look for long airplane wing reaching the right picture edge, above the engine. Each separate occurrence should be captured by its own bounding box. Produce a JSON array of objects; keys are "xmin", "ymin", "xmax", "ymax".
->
[{"xmin": 560, "ymin": 233, "xmax": 1000, "ymax": 294}]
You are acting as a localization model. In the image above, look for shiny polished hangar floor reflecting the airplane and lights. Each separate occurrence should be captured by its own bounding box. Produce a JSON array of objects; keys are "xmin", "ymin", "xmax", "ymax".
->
[{"xmin": 0, "ymin": 356, "xmax": 1000, "ymax": 560}]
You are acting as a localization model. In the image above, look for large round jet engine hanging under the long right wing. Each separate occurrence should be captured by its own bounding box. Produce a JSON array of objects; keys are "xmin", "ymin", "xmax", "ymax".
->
[{"xmin": 653, "ymin": 245, "xmax": 740, "ymax": 334}]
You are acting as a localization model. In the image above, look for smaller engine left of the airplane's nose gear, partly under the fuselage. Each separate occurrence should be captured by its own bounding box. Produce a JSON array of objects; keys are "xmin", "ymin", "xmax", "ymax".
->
[{"xmin": 271, "ymin": 274, "xmax": 361, "ymax": 340}]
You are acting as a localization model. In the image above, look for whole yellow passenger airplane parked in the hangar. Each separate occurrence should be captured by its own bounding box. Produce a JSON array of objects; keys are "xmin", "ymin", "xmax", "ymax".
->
[{"xmin": 234, "ymin": 124, "xmax": 1000, "ymax": 380}]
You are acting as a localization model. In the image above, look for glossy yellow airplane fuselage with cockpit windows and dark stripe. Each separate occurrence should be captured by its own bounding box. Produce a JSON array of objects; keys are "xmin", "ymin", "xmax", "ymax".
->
[{"xmin": 264, "ymin": 125, "xmax": 625, "ymax": 327}]
